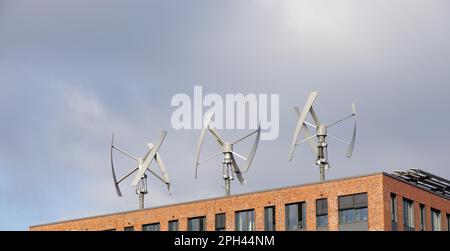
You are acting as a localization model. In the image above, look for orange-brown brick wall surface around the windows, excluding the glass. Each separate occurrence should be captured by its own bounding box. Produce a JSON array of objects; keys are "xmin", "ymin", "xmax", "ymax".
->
[{"xmin": 30, "ymin": 173, "xmax": 450, "ymax": 231}]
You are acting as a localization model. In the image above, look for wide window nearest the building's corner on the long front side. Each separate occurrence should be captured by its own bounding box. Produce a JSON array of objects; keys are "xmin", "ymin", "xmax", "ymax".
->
[{"xmin": 338, "ymin": 193, "xmax": 369, "ymax": 231}]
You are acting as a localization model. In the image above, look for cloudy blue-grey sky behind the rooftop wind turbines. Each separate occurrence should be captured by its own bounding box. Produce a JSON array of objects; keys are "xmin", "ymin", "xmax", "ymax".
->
[{"xmin": 0, "ymin": 0, "xmax": 450, "ymax": 230}]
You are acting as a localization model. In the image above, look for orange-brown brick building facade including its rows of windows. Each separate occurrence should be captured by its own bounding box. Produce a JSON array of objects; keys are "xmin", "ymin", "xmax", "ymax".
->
[{"xmin": 30, "ymin": 173, "xmax": 450, "ymax": 231}]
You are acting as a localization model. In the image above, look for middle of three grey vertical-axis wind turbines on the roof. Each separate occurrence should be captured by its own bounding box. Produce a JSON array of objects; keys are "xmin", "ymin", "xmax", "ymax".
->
[{"xmin": 195, "ymin": 112, "xmax": 261, "ymax": 196}]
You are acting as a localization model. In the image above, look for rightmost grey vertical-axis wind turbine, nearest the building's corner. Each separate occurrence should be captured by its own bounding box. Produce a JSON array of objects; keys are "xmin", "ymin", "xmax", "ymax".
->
[{"xmin": 289, "ymin": 91, "xmax": 356, "ymax": 181}]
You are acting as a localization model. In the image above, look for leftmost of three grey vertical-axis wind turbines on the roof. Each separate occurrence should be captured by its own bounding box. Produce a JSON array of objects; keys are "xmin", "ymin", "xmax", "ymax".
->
[{"xmin": 111, "ymin": 131, "xmax": 171, "ymax": 209}]
